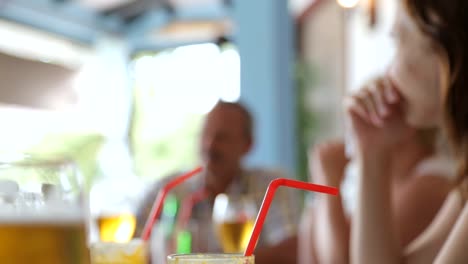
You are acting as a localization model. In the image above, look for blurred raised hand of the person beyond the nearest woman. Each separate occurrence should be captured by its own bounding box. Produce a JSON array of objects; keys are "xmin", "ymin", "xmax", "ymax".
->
[{"xmin": 309, "ymin": 142, "xmax": 348, "ymax": 187}]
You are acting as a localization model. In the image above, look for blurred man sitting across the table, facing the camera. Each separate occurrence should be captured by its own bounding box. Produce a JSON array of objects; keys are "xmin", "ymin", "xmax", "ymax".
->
[{"xmin": 138, "ymin": 102, "xmax": 301, "ymax": 264}]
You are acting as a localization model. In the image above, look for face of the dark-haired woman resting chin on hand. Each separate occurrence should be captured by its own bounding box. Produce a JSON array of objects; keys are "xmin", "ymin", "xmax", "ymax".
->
[{"xmin": 389, "ymin": 5, "xmax": 442, "ymax": 128}]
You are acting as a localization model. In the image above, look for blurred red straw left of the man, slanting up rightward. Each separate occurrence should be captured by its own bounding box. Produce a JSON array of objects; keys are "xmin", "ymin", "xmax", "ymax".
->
[{"xmin": 141, "ymin": 167, "xmax": 202, "ymax": 241}]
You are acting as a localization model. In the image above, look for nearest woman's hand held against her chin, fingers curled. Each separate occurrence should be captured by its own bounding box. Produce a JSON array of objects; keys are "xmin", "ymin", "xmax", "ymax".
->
[{"xmin": 345, "ymin": 77, "xmax": 415, "ymax": 155}]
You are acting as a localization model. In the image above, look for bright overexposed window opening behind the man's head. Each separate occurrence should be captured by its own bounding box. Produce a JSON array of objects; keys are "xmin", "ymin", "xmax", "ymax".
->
[{"xmin": 130, "ymin": 43, "xmax": 240, "ymax": 179}]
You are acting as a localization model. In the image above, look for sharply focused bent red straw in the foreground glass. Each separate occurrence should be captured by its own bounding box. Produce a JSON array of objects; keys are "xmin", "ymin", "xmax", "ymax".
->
[{"xmin": 244, "ymin": 178, "xmax": 339, "ymax": 256}]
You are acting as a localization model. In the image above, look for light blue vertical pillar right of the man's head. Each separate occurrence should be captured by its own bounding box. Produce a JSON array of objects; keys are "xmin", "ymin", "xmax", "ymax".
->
[{"xmin": 234, "ymin": 0, "xmax": 296, "ymax": 177}]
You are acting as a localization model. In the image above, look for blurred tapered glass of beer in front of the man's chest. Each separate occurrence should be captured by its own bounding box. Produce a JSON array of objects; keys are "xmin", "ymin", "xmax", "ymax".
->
[{"xmin": 213, "ymin": 194, "xmax": 257, "ymax": 253}]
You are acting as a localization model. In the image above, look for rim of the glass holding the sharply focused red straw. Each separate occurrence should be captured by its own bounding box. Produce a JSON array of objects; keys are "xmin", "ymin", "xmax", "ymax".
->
[{"xmin": 167, "ymin": 254, "xmax": 255, "ymax": 264}]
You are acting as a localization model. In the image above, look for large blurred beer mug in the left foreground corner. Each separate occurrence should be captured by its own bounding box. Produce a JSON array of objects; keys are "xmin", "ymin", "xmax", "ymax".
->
[{"xmin": 0, "ymin": 154, "xmax": 90, "ymax": 264}]
